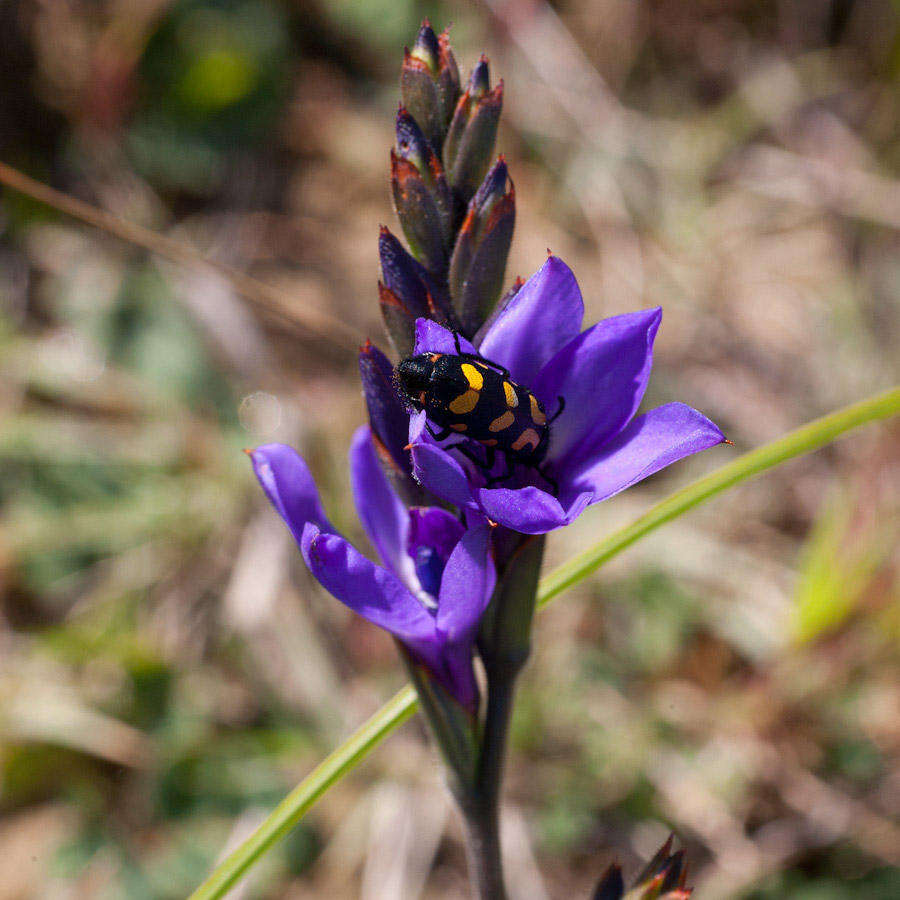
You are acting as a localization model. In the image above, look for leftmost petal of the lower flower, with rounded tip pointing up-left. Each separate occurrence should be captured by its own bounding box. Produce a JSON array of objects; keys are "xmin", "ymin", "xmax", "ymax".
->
[{"xmin": 249, "ymin": 444, "xmax": 334, "ymax": 544}]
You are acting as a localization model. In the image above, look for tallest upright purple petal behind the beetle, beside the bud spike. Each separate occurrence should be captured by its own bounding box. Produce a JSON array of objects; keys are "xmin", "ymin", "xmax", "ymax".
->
[{"xmin": 479, "ymin": 256, "xmax": 584, "ymax": 387}]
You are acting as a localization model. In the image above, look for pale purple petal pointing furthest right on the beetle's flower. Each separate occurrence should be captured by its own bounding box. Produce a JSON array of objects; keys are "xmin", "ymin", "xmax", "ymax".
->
[{"xmin": 571, "ymin": 403, "xmax": 725, "ymax": 503}]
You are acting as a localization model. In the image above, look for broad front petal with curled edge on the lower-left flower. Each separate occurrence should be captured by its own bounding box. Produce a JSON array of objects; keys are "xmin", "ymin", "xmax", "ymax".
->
[{"xmin": 300, "ymin": 523, "xmax": 438, "ymax": 662}]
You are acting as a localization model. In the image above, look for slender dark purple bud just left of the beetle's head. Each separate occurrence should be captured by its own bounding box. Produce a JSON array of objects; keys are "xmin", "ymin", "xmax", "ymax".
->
[{"xmin": 359, "ymin": 341, "xmax": 422, "ymax": 503}]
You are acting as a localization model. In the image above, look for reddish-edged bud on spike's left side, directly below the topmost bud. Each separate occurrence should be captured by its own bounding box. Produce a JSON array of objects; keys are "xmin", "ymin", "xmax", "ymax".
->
[{"xmin": 391, "ymin": 107, "xmax": 453, "ymax": 278}]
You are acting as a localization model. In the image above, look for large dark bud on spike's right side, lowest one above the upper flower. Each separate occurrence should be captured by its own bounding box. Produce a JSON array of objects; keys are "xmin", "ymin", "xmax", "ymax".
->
[{"xmin": 449, "ymin": 156, "xmax": 516, "ymax": 337}]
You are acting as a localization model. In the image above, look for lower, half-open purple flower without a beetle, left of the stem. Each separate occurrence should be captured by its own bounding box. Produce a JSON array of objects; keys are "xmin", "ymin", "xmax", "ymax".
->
[{"xmin": 250, "ymin": 426, "xmax": 495, "ymax": 709}]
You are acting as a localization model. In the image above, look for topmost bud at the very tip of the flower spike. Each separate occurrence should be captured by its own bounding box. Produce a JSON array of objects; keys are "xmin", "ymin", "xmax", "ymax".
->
[{"xmin": 400, "ymin": 19, "xmax": 459, "ymax": 151}]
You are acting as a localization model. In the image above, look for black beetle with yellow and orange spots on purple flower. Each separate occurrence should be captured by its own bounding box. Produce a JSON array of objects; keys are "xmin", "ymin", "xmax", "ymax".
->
[{"xmin": 397, "ymin": 332, "xmax": 565, "ymax": 493}]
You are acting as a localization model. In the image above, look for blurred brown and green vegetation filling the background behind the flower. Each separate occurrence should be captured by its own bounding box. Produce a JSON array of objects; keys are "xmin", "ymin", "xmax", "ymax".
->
[{"xmin": 0, "ymin": 0, "xmax": 900, "ymax": 900}]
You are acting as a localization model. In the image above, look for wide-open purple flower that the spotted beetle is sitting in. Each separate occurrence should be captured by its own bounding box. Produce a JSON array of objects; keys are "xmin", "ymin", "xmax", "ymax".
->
[{"xmin": 410, "ymin": 256, "xmax": 725, "ymax": 534}]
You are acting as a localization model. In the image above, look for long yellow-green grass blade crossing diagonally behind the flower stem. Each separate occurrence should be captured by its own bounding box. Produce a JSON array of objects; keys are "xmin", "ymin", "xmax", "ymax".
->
[{"xmin": 190, "ymin": 387, "xmax": 900, "ymax": 900}]
